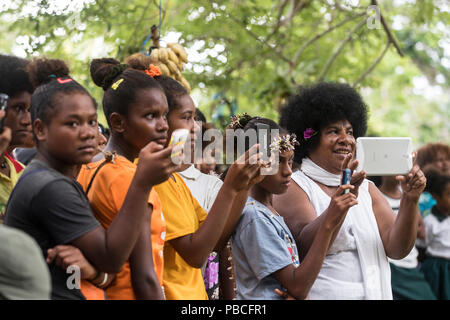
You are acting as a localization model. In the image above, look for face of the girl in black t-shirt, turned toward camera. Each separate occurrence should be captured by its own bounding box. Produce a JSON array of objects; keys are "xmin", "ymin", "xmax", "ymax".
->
[{"xmin": 39, "ymin": 93, "xmax": 98, "ymax": 165}]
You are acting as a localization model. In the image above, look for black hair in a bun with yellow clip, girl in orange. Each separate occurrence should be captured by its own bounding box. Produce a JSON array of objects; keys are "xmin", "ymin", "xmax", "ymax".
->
[{"xmin": 90, "ymin": 58, "xmax": 162, "ymax": 127}]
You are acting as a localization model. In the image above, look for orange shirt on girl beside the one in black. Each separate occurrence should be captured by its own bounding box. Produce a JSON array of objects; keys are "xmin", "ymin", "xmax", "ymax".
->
[{"xmin": 78, "ymin": 156, "xmax": 166, "ymax": 300}]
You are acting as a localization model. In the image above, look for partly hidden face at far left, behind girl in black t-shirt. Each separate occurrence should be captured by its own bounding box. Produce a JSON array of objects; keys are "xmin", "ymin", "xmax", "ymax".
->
[{"xmin": 5, "ymin": 91, "xmax": 34, "ymax": 148}]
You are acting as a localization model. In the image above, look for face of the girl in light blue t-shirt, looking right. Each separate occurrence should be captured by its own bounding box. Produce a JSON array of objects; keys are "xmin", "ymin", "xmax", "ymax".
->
[{"xmin": 259, "ymin": 151, "xmax": 294, "ymax": 194}]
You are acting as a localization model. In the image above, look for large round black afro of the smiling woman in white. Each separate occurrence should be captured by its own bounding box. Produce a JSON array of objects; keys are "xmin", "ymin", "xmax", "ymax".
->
[{"xmin": 279, "ymin": 82, "xmax": 368, "ymax": 163}]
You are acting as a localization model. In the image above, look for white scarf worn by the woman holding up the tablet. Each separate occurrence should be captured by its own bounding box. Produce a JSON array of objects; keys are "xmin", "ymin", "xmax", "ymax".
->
[{"xmin": 301, "ymin": 158, "xmax": 392, "ymax": 300}]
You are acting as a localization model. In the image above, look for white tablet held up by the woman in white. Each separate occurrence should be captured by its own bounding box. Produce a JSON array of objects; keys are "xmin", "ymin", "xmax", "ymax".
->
[{"xmin": 356, "ymin": 137, "xmax": 413, "ymax": 176}]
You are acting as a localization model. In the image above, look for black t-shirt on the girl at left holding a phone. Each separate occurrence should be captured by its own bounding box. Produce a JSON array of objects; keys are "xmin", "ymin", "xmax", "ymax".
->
[{"xmin": 5, "ymin": 160, "xmax": 100, "ymax": 299}]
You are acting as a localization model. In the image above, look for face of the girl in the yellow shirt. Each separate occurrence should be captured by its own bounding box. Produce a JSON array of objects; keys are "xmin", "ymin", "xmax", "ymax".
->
[{"xmin": 168, "ymin": 94, "xmax": 199, "ymax": 147}]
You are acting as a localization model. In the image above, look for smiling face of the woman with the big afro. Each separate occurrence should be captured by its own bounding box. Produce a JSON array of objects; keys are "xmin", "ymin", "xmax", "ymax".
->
[{"xmin": 309, "ymin": 120, "xmax": 356, "ymax": 174}]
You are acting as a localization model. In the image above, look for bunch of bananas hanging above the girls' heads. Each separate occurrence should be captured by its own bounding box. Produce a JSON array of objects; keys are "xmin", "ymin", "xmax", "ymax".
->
[{"xmin": 150, "ymin": 43, "xmax": 191, "ymax": 92}]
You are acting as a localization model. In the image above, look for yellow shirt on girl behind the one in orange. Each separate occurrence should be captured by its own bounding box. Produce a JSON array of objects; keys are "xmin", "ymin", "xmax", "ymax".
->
[{"xmin": 155, "ymin": 173, "xmax": 208, "ymax": 300}]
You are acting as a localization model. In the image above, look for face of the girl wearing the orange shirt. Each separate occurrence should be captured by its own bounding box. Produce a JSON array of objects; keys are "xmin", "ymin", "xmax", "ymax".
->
[{"xmin": 123, "ymin": 89, "xmax": 169, "ymax": 152}]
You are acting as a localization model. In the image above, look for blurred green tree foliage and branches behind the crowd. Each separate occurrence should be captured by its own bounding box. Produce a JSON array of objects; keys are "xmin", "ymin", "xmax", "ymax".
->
[{"xmin": 0, "ymin": 0, "xmax": 450, "ymax": 147}]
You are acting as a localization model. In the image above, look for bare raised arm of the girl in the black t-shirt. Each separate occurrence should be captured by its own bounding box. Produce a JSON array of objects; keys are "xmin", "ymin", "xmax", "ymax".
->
[{"xmin": 71, "ymin": 142, "xmax": 177, "ymax": 273}]
